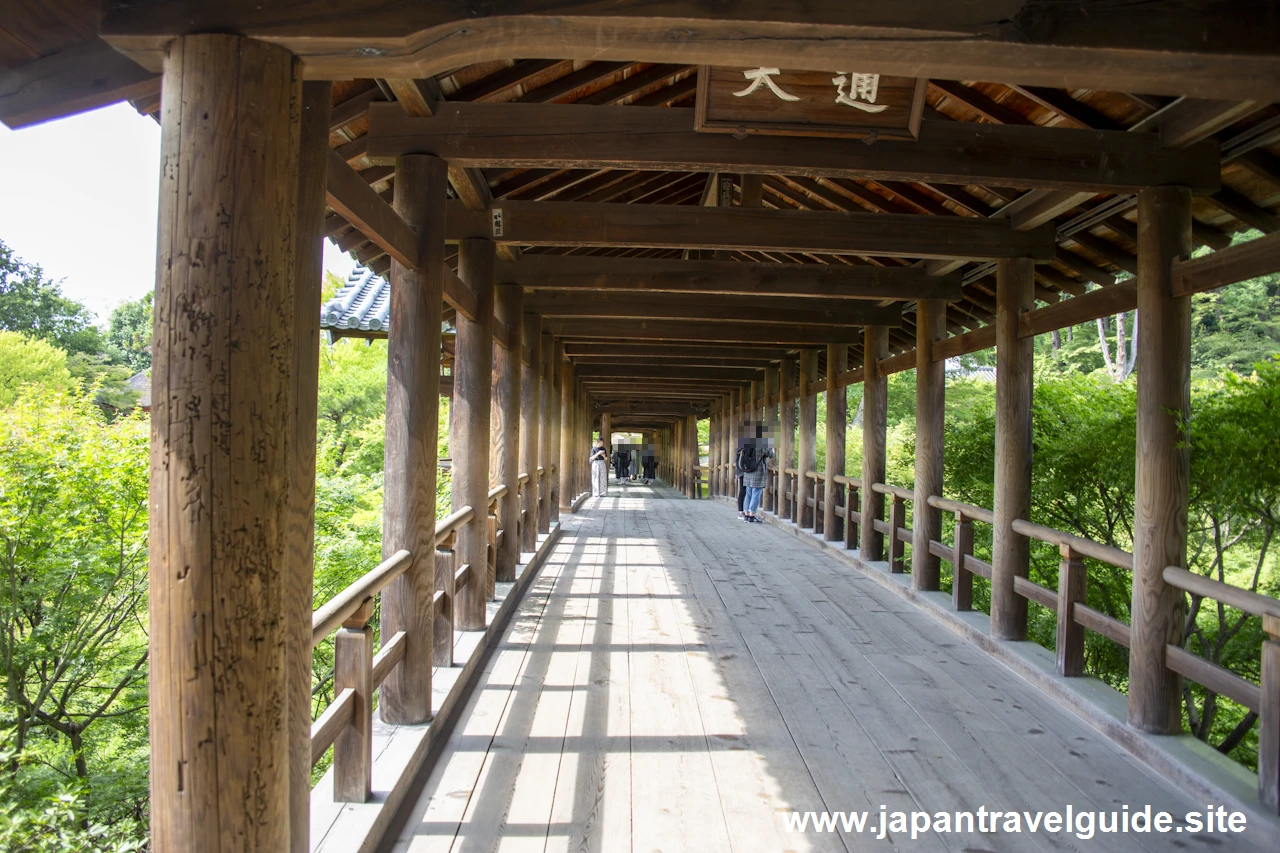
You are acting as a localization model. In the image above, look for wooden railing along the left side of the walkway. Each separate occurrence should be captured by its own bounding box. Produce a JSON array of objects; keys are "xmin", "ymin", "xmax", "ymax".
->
[{"xmin": 311, "ymin": 474, "xmax": 517, "ymax": 803}]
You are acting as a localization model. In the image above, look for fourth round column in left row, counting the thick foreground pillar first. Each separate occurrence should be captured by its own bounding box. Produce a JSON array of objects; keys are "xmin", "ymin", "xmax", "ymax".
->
[{"xmin": 492, "ymin": 284, "xmax": 525, "ymax": 583}]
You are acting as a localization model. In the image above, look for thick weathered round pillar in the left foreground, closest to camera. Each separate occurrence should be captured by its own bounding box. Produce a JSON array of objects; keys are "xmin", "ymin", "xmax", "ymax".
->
[{"xmin": 150, "ymin": 35, "xmax": 300, "ymax": 850}]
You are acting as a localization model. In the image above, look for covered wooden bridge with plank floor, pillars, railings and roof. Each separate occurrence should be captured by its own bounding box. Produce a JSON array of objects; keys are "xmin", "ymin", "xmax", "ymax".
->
[{"xmin": 0, "ymin": 0, "xmax": 1280, "ymax": 853}]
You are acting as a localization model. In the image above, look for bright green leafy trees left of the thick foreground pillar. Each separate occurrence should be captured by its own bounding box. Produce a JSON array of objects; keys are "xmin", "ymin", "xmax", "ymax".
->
[{"xmin": 0, "ymin": 388, "xmax": 148, "ymax": 849}]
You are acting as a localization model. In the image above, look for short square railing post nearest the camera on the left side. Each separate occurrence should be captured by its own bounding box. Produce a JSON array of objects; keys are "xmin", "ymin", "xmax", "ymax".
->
[{"xmin": 333, "ymin": 598, "xmax": 374, "ymax": 803}]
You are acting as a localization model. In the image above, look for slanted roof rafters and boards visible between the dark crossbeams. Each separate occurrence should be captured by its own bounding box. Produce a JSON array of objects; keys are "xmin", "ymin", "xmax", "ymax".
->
[{"xmin": 304, "ymin": 59, "xmax": 1280, "ymax": 414}]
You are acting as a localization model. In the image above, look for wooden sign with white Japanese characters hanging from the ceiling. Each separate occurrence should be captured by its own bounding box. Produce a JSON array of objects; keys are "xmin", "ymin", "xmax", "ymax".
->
[{"xmin": 694, "ymin": 65, "xmax": 927, "ymax": 140}]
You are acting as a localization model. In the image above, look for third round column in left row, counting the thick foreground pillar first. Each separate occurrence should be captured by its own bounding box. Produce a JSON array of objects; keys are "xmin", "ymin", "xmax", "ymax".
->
[{"xmin": 449, "ymin": 238, "xmax": 497, "ymax": 631}]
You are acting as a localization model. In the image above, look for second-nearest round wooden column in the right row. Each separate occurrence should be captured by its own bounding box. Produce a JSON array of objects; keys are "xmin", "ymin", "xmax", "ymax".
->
[{"xmin": 991, "ymin": 259, "xmax": 1036, "ymax": 640}]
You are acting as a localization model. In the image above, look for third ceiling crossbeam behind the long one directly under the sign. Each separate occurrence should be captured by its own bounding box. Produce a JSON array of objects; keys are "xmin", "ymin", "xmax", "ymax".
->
[{"xmin": 525, "ymin": 291, "xmax": 902, "ymax": 325}]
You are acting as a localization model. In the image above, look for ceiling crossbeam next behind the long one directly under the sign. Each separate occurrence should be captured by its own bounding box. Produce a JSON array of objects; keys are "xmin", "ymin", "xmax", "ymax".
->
[{"xmin": 449, "ymin": 201, "xmax": 1053, "ymax": 260}]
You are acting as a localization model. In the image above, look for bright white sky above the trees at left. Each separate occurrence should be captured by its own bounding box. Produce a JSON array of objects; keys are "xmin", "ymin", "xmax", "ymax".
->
[{"xmin": 0, "ymin": 104, "xmax": 355, "ymax": 323}]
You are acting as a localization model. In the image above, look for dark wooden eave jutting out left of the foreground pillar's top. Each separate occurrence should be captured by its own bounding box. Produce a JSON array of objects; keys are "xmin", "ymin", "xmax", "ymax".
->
[{"xmin": 0, "ymin": 36, "xmax": 160, "ymax": 131}]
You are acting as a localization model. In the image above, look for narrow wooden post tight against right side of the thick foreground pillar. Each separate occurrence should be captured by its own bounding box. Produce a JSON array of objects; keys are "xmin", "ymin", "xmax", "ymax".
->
[{"xmin": 284, "ymin": 81, "xmax": 332, "ymax": 853}]
